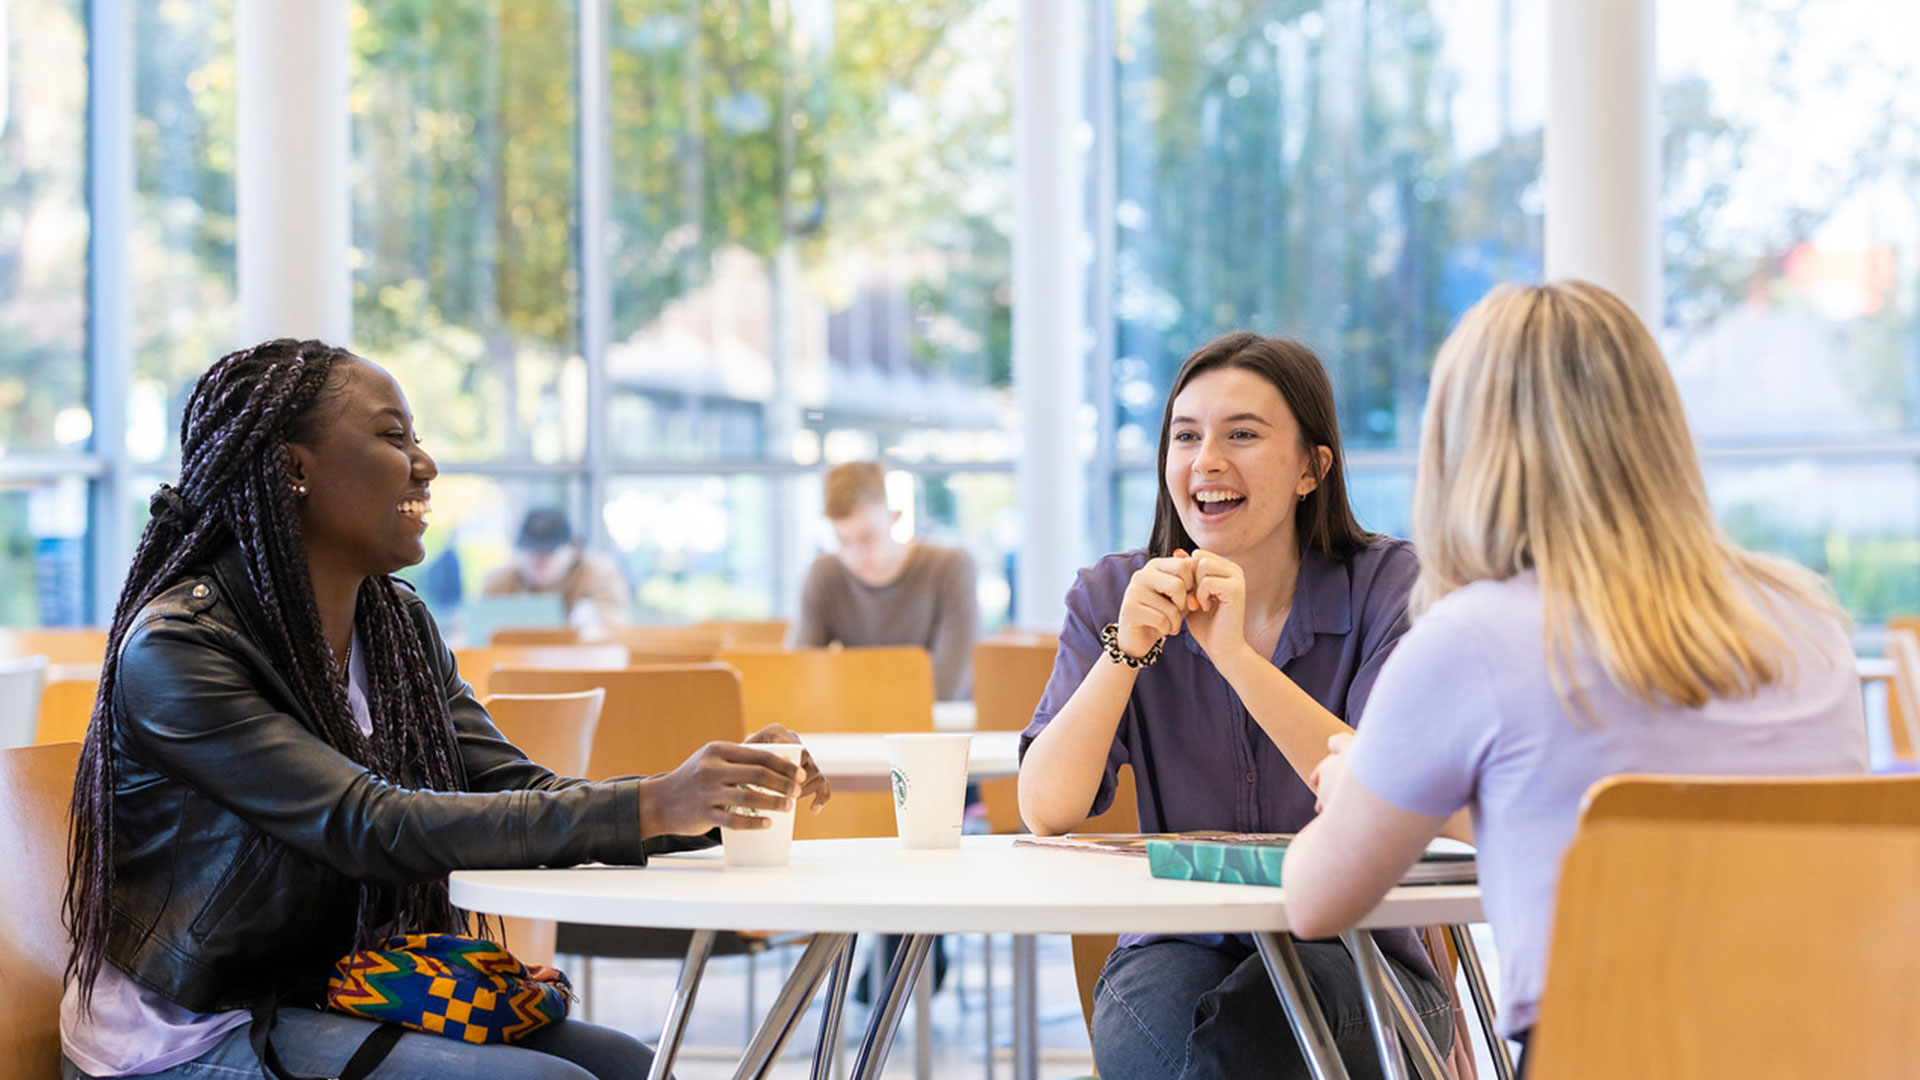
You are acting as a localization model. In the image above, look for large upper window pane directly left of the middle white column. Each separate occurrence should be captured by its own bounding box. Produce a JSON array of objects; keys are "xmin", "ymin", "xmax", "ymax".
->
[{"xmin": 607, "ymin": 0, "xmax": 1014, "ymax": 465}]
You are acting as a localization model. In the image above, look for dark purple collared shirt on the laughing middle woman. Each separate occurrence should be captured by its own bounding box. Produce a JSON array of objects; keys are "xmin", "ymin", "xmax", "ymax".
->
[{"xmin": 1020, "ymin": 538, "xmax": 1432, "ymax": 972}]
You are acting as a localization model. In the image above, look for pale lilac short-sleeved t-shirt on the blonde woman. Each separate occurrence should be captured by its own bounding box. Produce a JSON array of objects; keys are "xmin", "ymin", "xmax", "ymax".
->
[{"xmin": 1348, "ymin": 573, "xmax": 1866, "ymax": 1034}]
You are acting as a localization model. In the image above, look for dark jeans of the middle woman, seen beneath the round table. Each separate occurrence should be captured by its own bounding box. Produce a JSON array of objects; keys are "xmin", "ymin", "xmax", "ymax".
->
[{"xmin": 1092, "ymin": 942, "xmax": 1453, "ymax": 1080}]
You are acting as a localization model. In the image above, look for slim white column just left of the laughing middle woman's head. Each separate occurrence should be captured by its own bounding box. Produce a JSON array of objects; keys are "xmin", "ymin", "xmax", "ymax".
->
[{"xmin": 1014, "ymin": 0, "xmax": 1087, "ymax": 628}]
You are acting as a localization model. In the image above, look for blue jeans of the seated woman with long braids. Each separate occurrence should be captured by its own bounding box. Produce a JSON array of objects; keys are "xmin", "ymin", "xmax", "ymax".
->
[{"xmin": 60, "ymin": 1007, "xmax": 653, "ymax": 1080}]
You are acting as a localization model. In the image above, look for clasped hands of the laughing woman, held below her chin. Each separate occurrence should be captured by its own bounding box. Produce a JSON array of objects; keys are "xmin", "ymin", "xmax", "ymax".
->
[{"xmin": 1116, "ymin": 548, "xmax": 1246, "ymax": 663}]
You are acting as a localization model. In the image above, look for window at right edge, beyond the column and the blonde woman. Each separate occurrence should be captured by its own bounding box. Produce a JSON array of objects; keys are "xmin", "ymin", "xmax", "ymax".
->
[{"xmin": 1659, "ymin": 0, "xmax": 1920, "ymax": 623}]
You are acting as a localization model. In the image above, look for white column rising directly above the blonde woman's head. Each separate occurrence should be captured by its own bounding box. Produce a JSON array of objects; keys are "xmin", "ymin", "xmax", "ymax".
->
[{"xmin": 1546, "ymin": 0, "xmax": 1661, "ymax": 332}]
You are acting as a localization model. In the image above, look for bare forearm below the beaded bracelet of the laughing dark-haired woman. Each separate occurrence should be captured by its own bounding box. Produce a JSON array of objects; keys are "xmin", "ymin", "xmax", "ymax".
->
[{"xmin": 1020, "ymin": 659, "xmax": 1140, "ymax": 836}]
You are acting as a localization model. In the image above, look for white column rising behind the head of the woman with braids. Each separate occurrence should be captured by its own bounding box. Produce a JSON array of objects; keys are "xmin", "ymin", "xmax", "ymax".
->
[{"xmin": 234, "ymin": 0, "xmax": 353, "ymax": 344}]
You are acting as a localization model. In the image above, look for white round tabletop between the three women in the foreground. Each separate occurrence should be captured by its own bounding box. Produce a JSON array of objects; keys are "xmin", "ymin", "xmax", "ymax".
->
[{"xmin": 451, "ymin": 836, "xmax": 1480, "ymax": 1072}]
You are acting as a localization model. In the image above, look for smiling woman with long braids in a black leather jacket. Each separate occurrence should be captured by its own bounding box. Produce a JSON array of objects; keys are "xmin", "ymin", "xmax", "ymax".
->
[{"xmin": 61, "ymin": 340, "xmax": 828, "ymax": 1080}]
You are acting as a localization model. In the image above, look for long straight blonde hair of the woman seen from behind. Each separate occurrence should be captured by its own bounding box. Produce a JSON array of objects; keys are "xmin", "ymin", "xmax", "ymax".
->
[{"xmin": 1413, "ymin": 281, "xmax": 1843, "ymax": 717}]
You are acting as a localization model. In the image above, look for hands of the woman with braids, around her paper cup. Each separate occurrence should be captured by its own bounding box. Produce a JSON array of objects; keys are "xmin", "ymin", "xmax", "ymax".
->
[{"xmin": 639, "ymin": 724, "xmax": 833, "ymax": 836}]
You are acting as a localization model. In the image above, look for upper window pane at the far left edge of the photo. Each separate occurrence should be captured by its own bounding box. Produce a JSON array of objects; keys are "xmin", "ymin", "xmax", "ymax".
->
[{"xmin": 0, "ymin": 0, "xmax": 92, "ymax": 451}]
